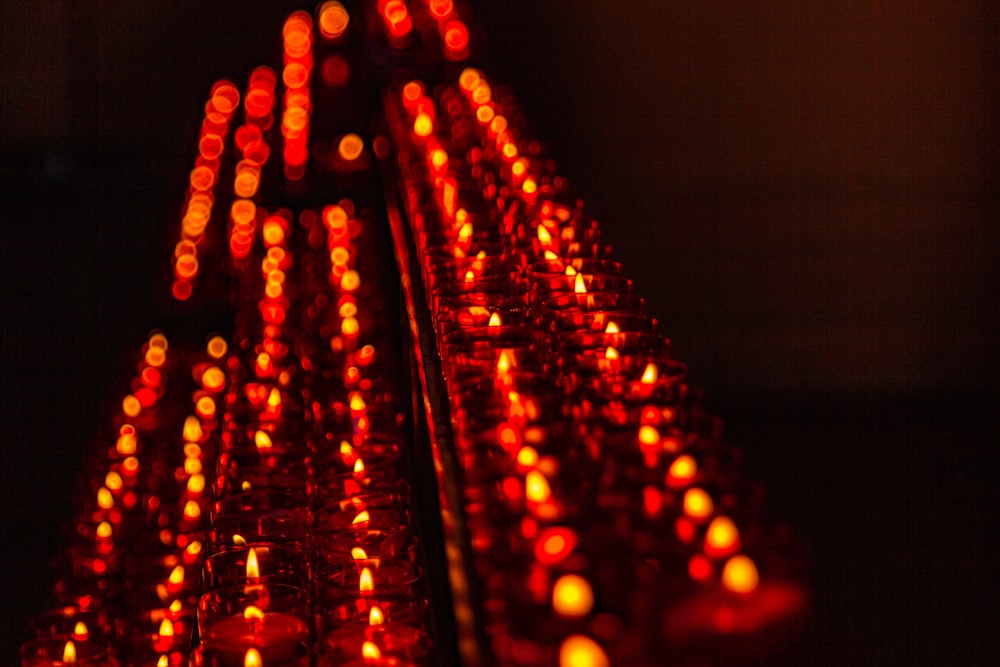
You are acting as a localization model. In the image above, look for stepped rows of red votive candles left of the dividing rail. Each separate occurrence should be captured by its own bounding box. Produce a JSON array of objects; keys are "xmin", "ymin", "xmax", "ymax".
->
[{"xmin": 21, "ymin": 2, "xmax": 454, "ymax": 667}]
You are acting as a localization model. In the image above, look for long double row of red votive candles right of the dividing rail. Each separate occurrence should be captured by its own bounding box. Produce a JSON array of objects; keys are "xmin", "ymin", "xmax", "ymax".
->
[{"xmin": 385, "ymin": 68, "xmax": 802, "ymax": 667}]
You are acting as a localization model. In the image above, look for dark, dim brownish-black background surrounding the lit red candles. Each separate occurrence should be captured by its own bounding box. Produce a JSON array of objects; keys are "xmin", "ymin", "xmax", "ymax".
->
[{"xmin": 0, "ymin": 0, "xmax": 1000, "ymax": 665}]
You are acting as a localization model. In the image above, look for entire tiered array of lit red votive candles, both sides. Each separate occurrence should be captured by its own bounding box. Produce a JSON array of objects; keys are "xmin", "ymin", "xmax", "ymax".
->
[{"xmin": 22, "ymin": 0, "xmax": 803, "ymax": 667}]
